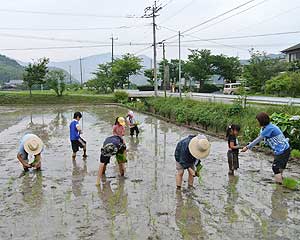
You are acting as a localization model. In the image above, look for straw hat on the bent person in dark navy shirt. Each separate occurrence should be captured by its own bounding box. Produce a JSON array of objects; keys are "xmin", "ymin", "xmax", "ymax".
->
[{"xmin": 189, "ymin": 134, "xmax": 210, "ymax": 159}]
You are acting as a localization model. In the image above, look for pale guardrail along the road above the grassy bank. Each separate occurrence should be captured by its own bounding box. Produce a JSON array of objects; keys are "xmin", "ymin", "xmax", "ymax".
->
[{"xmin": 121, "ymin": 90, "xmax": 300, "ymax": 106}]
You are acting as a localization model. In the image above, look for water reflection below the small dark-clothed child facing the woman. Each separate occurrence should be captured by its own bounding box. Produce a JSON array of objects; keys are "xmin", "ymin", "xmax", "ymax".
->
[{"xmin": 225, "ymin": 176, "xmax": 239, "ymax": 223}]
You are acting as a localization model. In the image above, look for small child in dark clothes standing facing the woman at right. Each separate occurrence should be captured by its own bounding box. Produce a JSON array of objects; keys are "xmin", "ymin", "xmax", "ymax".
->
[{"xmin": 226, "ymin": 124, "xmax": 241, "ymax": 175}]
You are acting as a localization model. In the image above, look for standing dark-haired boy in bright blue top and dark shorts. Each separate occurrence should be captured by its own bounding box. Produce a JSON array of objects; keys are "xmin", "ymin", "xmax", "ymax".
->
[{"xmin": 70, "ymin": 112, "xmax": 87, "ymax": 160}]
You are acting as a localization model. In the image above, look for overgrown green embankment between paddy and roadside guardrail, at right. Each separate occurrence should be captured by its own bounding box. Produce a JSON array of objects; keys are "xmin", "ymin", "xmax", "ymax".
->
[{"xmin": 127, "ymin": 98, "xmax": 300, "ymax": 158}]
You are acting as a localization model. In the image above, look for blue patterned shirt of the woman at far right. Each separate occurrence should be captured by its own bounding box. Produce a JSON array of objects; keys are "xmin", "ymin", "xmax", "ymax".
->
[{"xmin": 248, "ymin": 123, "xmax": 290, "ymax": 155}]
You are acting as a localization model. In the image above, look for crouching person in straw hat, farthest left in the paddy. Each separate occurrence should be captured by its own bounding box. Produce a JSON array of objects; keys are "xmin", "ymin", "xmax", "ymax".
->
[{"xmin": 17, "ymin": 134, "xmax": 44, "ymax": 172}]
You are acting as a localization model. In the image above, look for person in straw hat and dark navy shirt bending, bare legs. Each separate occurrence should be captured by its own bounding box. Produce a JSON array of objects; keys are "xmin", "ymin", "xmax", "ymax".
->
[{"xmin": 175, "ymin": 134, "xmax": 210, "ymax": 189}]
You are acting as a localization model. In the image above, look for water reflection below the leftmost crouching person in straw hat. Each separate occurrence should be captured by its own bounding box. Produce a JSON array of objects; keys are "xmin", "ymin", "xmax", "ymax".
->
[{"xmin": 20, "ymin": 171, "xmax": 44, "ymax": 211}]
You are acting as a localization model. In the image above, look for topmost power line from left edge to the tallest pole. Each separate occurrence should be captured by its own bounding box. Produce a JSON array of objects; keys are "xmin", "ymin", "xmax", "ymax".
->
[{"xmin": 0, "ymin": 9, "xmax": 140, "ymax": 18}]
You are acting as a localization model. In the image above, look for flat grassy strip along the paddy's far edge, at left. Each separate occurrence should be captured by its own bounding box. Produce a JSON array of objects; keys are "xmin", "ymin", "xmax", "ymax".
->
[{"xmin": 0, "ymin": 91, "xmax": 114, "ymax": 105}]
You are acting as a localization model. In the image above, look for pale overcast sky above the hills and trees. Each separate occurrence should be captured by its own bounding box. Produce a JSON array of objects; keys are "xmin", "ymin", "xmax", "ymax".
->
[{"xmin": 0, "ymin": 0, "xmax": 300, "ymax": 61}]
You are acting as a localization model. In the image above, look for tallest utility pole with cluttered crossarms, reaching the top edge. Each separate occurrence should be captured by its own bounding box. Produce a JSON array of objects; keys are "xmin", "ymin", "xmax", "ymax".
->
[{"xmin": 143, "ymin": 1, "xmax": 162, "ymax": 97}]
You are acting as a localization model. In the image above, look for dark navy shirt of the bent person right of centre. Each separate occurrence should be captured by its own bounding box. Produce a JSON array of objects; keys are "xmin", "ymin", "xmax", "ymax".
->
[{"xmin": 175, "ymin": 135, "xmax": 197, "ymax": 169}]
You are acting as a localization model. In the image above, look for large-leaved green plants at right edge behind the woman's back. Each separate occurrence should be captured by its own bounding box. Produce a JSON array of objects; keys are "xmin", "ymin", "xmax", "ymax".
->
[{"xmin": 271, "ymin": 112, "xmax": 300, "ymax": 149}]
